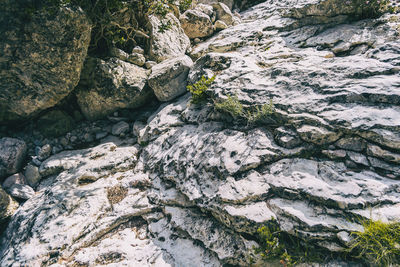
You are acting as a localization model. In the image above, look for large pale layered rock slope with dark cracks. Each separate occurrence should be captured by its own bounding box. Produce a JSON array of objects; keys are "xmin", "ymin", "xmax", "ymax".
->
[{"xmin": 0, "ymin": 0, "xmax": 400, "ymax": 266}]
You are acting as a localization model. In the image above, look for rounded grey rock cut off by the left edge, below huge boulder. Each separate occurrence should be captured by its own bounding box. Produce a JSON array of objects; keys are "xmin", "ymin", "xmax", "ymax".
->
[{"xmin": 0, "ymin": 137, "xmax": 27, "ymax": 179}]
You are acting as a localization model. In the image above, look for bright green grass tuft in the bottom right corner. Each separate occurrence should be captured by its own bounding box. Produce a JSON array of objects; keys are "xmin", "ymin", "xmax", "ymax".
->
[{"xmin": 350, "ymin": 220, "xmax": 400, "ymax": 266}]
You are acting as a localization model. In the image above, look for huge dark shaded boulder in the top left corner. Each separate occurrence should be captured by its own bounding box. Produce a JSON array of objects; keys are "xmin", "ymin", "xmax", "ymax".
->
[{"xmin": 0, "ymin": 0, "xmax": 91, "ymax": 122}]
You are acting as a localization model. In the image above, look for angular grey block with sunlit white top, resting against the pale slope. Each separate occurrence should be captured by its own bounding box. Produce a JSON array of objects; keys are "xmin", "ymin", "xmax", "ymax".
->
[{"xmin": 148, "ymin": 56, "xmax": 193, "ymax": 101}]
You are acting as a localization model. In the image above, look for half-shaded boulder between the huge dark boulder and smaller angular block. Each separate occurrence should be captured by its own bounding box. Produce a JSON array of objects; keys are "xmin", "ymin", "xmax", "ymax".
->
[{"xmin": 76, "ymin": 58, "xmax": 151, "ymax": 120}]
